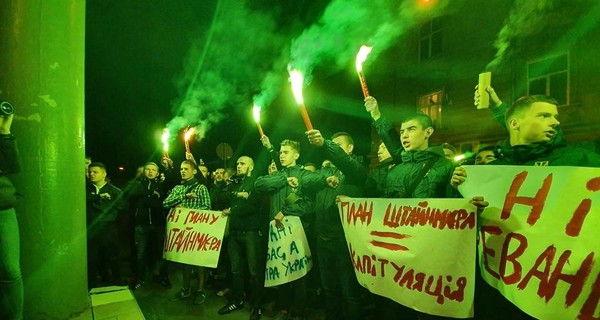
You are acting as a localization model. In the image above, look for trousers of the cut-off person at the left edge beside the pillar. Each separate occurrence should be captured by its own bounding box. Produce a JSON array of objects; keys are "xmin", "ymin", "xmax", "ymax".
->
[{"xmin": 0, "ymin": 209, "xmax": 23, "ymax": 320}]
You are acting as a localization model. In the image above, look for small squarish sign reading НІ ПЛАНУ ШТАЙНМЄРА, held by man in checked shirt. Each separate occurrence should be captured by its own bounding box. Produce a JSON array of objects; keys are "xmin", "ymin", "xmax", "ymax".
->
[{"xmin": 164, "ymin": 207, "xmax": 227, "ymax": 268}]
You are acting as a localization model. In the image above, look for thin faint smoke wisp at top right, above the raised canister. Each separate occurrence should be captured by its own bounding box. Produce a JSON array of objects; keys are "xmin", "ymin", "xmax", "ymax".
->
[{"xmin": 486, "ymin": 0, "xmax": 554, "ymax": 71}]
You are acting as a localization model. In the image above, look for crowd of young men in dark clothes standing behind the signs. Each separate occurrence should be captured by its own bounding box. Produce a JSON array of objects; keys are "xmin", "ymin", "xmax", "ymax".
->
[{"xmin": 86, "ymin": 88, "xmax": 600, "ymax": 319}]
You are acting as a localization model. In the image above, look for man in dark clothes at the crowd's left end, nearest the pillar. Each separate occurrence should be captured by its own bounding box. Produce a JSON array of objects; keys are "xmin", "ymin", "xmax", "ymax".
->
[{"xmin": 86, "ymin": 162, "xmax": 125, "ymax": 288}]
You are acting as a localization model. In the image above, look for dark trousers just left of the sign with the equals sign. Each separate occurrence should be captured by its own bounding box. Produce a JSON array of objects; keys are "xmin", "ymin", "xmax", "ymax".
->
[{"xmin": 317, "ymin": 236, "xmax": 363, "ymax": 320}]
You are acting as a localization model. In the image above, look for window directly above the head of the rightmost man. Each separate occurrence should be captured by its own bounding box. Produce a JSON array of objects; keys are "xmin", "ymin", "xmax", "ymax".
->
[{"xmin": 527, "ymin": 53, "xmax": 569, "ymax": 105}]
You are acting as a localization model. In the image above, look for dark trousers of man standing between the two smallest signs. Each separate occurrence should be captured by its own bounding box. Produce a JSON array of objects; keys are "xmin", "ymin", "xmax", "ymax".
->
[{"xmin": 227, "ymin": 231, "xmax": 266, "ymax": 306}]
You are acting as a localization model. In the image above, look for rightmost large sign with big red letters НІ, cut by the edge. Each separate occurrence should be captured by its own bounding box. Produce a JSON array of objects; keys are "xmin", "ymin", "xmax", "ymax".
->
[{"xmin": 459, "ymin": 166, "xmax": 600, "ymax": 320}]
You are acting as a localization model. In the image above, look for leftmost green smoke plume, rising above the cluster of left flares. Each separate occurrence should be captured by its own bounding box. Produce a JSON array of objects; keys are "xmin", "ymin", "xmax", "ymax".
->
[{"xmin": 167, "ymin": 0, "xmax": 284, "ymax": 139}]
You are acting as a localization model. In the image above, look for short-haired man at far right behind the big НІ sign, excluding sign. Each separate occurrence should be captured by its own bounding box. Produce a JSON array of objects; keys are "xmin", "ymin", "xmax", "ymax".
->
[{"xmin": 451, "ymin": 95, "xmax": 600, "ymax": 319}]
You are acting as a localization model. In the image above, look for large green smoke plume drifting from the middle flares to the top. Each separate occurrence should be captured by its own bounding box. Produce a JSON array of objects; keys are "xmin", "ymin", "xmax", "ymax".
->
[{"xmin": 254, "ymin": 0, "xmax": 454, "ymax": 106}]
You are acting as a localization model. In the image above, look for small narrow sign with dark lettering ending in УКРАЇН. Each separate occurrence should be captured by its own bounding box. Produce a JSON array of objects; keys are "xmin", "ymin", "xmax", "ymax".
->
[{"xmin": 265, "ymin": 216, "xmax": 313, "ymax": 287}]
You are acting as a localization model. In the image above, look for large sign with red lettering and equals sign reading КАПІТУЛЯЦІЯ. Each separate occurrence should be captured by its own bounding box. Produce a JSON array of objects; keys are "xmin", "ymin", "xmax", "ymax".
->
[{"xmin": 339, "ymin": 198, "xmax": 476, "ymax": 318}]
